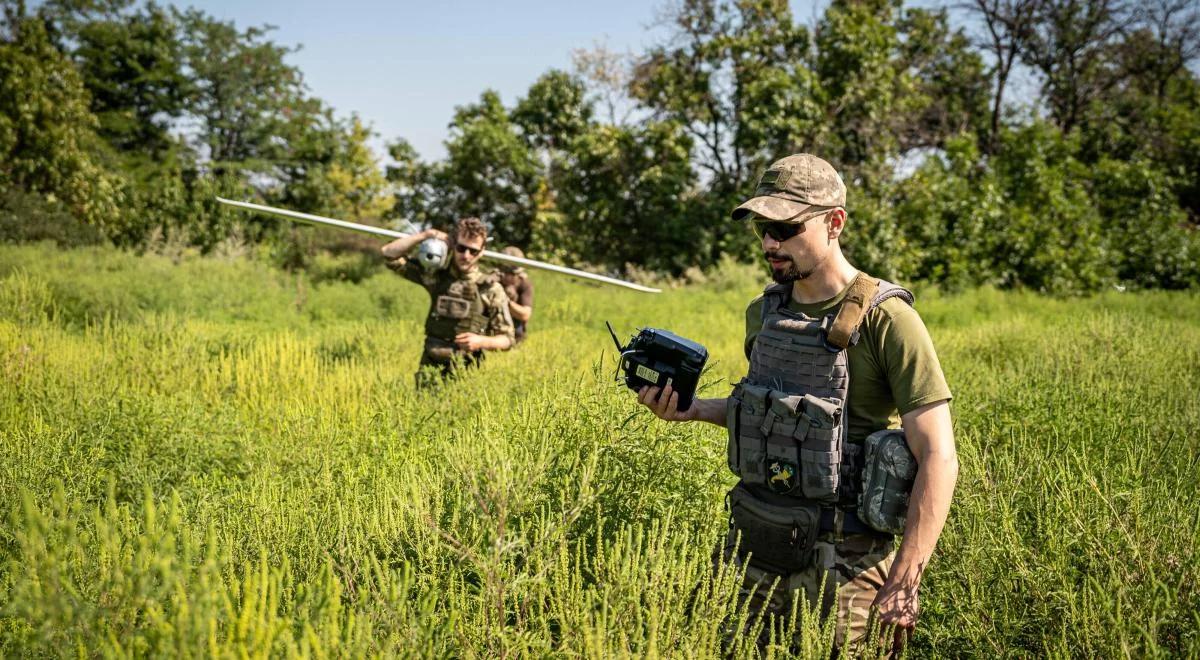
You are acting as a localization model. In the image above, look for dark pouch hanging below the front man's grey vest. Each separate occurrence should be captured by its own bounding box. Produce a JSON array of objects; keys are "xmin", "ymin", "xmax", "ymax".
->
[{"xmin": 730, "ymin": 484, "xmax": 821, "ymax": 575}]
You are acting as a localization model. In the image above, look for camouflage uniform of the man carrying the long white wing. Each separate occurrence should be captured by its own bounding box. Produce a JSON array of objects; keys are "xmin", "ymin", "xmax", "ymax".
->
[{"xmin": 388, "ymin": 257, "xmax": 514, "ymax": 385}]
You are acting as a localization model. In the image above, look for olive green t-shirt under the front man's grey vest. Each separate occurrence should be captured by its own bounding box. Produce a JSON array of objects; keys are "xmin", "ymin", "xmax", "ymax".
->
[{"xmin": 745, "ymin": 280, "xmax": 950, "ymax": 442}]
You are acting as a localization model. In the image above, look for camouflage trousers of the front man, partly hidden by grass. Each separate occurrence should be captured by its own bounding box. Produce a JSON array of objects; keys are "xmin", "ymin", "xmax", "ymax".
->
[{"xmin": 724, "ymin": 529, "xmax": 895, "ymax": 650}]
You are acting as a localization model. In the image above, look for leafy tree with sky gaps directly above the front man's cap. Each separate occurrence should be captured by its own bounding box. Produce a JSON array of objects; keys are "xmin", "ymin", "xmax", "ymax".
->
[{"xmin": 631, "ymin": 0, "xmax": 820, "ymax": 194}]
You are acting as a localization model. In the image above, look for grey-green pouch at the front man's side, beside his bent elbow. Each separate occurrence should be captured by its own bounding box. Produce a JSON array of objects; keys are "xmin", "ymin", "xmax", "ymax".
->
[{"xmin": 858, "ymin": 428, "xmax": 917, "ymax": 534}]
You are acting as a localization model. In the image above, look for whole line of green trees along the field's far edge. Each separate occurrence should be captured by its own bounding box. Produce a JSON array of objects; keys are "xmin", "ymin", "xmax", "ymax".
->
[{"xmin": 0, "ymin": 0, "xmax": 1200, "ymax": 294}]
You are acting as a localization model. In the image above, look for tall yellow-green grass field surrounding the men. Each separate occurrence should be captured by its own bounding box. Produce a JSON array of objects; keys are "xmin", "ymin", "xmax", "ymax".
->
[{"xmin": 0, "ymin": 246, "xmax": 1200, "ymax": 658}]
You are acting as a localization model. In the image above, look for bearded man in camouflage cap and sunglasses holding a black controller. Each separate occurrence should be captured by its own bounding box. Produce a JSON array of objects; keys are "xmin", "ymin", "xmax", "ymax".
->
[{"xmin": 638, "ymin": 154, "xmax": 958, "ymax": 652}]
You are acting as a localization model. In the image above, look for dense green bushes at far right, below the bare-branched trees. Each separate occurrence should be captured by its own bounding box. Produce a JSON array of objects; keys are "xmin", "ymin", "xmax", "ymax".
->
[{"xmin": 892, "ymin": 125, "xmax": 1200, "ymax": 293}]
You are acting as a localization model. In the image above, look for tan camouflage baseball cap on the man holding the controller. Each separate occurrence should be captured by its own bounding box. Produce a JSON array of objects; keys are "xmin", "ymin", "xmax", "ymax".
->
[{"xmin": 732, "ymin": 154, "xmax": 846, "ymax": 221}]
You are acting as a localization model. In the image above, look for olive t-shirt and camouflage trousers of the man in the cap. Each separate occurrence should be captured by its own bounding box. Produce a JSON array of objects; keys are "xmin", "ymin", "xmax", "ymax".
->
[{"xmin": 725, "ymin": 279, "xmax": 950, "ymax": 646}]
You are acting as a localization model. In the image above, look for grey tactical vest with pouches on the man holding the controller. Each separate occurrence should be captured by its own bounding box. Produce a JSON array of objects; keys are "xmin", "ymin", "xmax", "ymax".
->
[{"xmin": 727, "ymin": 274, "xmax": 917, "ymax": 575}]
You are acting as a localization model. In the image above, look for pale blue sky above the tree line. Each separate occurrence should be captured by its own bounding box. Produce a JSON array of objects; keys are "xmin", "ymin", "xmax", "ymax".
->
[{"xmin": 179, "ymin": 0, "xmax": 844, "ymax": 160}]
